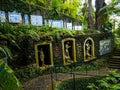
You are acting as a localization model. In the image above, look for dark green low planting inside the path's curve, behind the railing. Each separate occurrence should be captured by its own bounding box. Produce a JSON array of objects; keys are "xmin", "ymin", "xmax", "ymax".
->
[{"xmin": 56, "ymin": 76, "xmax": 103, "ymax": 90}]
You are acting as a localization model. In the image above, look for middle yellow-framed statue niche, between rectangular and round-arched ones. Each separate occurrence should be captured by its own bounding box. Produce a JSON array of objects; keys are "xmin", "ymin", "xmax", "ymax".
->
[{"xmin": 62, "ymin": 38, "xmax": 76, "ymax": 64}]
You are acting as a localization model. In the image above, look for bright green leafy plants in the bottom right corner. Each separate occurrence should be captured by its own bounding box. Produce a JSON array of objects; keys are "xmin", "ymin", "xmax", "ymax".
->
[{"xmin": 88, "ymin": 70, "xmax": 120, "ymax": 90}]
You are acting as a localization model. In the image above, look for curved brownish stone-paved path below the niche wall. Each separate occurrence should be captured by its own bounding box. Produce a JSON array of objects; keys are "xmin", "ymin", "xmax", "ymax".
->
[{"xmin": 23, "ymin": 68, "xmax": 109, "ymax": 90}]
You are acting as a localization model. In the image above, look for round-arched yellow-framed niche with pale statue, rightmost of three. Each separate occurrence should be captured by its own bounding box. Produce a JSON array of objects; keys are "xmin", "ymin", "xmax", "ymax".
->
[{"xmin": 84, "ymin": 37, "xmax": 95, "ymax": 62}]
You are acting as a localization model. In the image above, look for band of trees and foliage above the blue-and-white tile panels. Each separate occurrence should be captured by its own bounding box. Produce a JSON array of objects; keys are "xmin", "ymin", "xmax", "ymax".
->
[{"xmin": 0, "ymin": 0, "xmax": 120, "ymax": 31}]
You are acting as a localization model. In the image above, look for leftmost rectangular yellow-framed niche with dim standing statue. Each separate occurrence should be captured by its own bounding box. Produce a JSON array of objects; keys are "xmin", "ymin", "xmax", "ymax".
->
[{"xmin": 35, "ymin": 42, "xmax": 53, "ymax": 67}]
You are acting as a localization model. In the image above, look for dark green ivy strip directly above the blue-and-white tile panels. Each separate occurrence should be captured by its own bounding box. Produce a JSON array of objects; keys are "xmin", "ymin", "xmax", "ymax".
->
[{"xmin": 0, "ymin": 0, "xmax": 79, "ymax": 22}]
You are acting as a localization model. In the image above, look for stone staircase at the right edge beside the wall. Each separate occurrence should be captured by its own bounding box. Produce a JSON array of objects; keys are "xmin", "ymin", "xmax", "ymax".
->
[{"xmin": 109, "ymin": 49, "xmax": 120, "ymax": 69}]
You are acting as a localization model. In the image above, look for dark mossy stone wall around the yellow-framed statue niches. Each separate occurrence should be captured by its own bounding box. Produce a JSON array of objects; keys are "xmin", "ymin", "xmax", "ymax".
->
[{"xmin": 16, "ymin": 33, "xmax": 114, "ymax": 65}]
